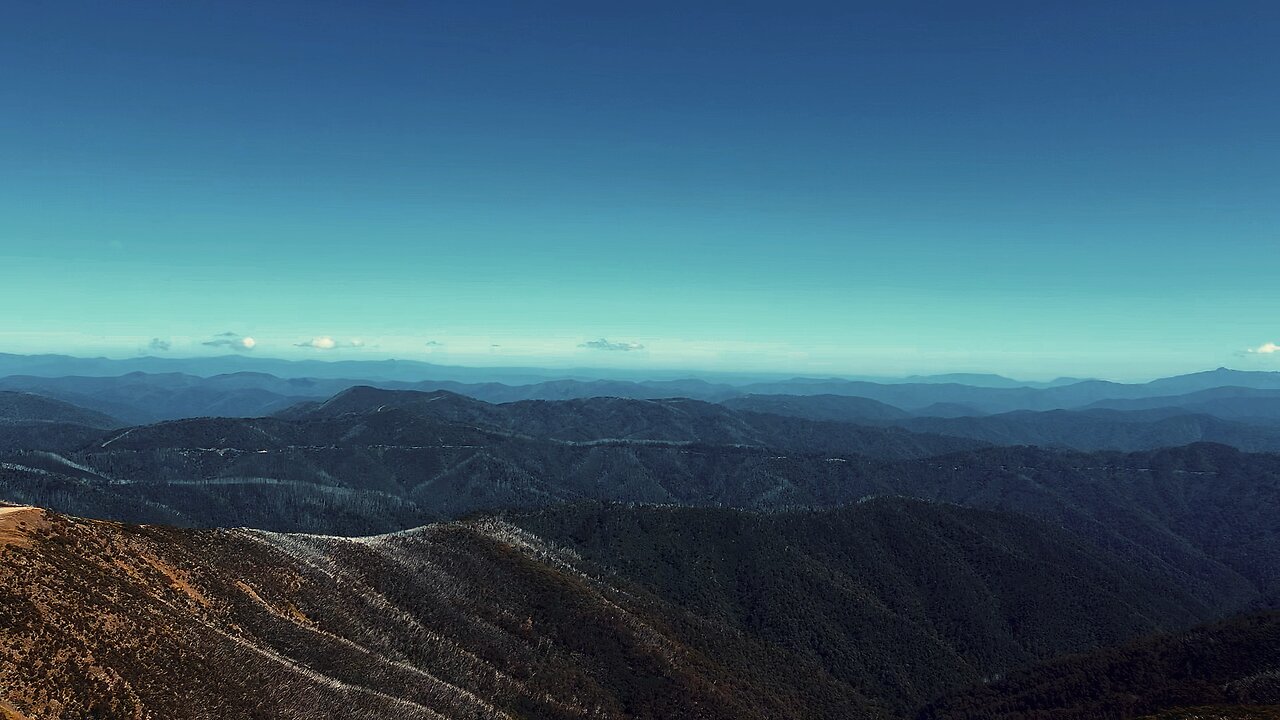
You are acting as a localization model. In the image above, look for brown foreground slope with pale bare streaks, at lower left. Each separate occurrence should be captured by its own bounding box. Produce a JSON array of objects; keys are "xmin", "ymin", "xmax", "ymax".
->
[{"xmin": 0, "ymin": 510, "xmax": 868, "ymax": 720}]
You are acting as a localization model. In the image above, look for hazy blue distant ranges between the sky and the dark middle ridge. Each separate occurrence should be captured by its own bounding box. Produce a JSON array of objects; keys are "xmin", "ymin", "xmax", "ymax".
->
[{"xmin": 0, "ymin": 370, "xmax": 1280, "ymax": 452}]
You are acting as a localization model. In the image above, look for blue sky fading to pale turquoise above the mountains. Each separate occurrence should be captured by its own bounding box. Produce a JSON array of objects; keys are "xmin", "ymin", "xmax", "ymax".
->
[{"xmin": 0, "ymin": 1, "xmax": 1280, "ymax": 378}]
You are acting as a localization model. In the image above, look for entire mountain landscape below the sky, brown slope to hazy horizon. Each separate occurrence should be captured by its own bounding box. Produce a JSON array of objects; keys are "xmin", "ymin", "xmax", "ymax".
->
[{"xmin": 0, "ymin": 356, "xmax": 1280, "ymax": 720}]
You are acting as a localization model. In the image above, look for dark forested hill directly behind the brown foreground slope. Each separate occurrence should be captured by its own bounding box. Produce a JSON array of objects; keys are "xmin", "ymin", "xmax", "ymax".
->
[{"xmin": 513, "ymin": 498, "xmax": 1211, "ymax": 712}]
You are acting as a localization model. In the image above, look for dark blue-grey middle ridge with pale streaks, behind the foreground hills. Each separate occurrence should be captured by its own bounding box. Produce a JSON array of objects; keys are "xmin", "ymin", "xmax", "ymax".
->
[{"xmin": 0, "ymin": 420, "xmax": 1280, "ymax": 610}]
